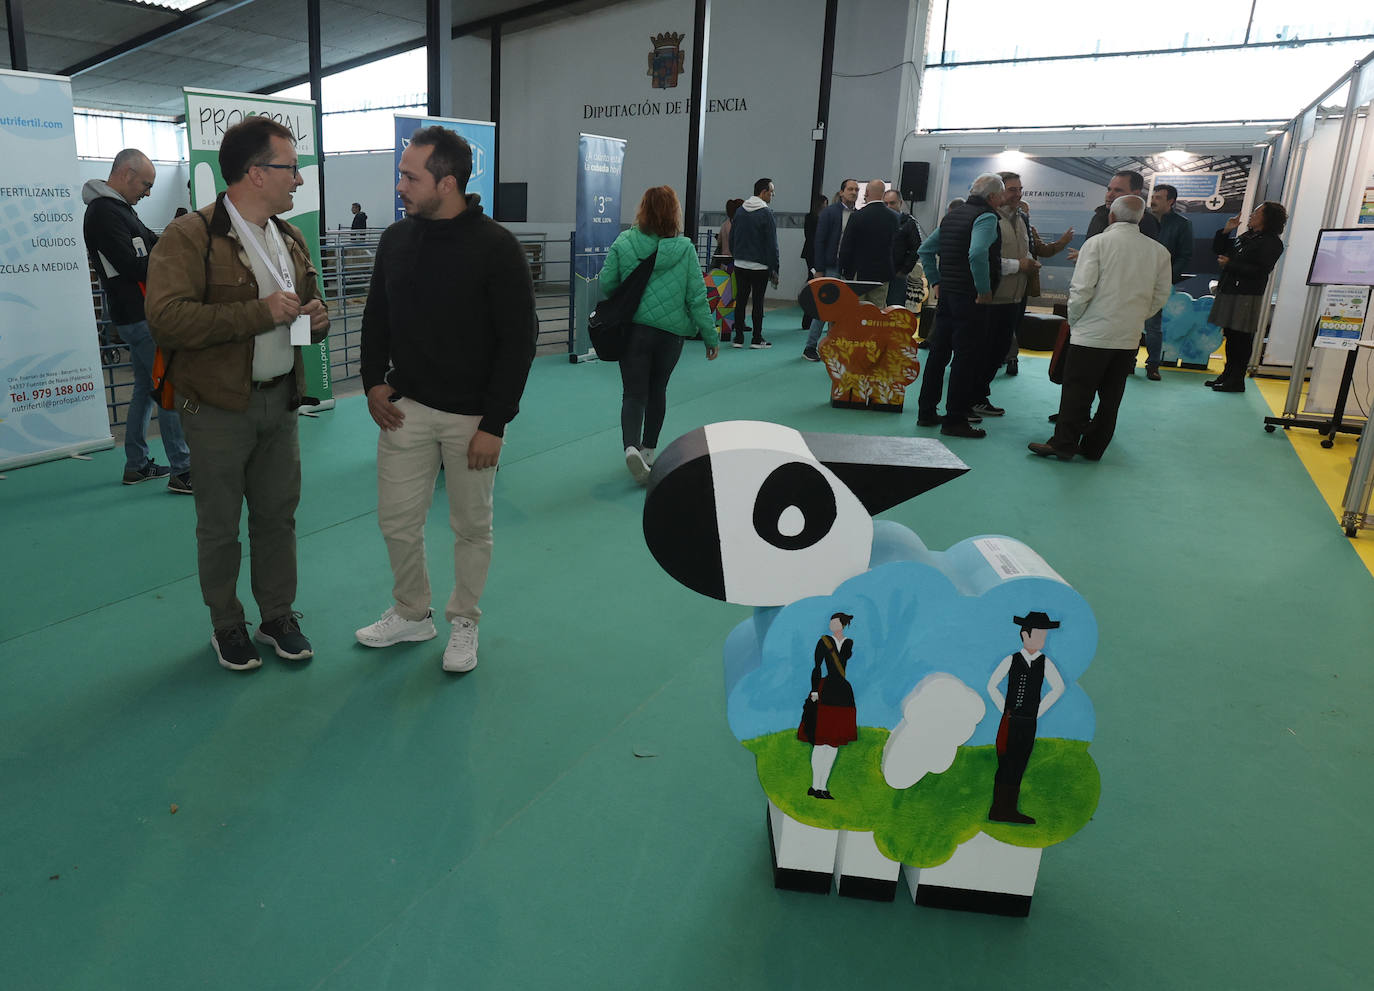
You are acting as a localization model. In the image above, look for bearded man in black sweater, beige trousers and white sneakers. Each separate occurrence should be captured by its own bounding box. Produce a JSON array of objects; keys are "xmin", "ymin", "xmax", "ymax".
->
[{"xmin": 357, "ymin": 126, "xmax": 539, "ymax": 672}]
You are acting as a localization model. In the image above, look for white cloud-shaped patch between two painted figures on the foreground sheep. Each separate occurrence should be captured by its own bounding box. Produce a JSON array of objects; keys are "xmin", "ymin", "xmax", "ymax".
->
[{"xmin": 882, "ymin": 671, "xmax": 987, "ymax": 789}]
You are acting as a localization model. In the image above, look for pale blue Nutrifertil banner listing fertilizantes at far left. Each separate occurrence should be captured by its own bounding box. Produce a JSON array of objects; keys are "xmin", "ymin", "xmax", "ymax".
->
[{"xmin": 0, "ymin": 70, "xmax": 114, "ymax": 469}]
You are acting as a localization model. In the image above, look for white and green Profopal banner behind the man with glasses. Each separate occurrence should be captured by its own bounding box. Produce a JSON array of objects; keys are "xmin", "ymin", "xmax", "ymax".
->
[{"xmin": 184, "ymin": 88, "xmax": 334, "ymax": 410}]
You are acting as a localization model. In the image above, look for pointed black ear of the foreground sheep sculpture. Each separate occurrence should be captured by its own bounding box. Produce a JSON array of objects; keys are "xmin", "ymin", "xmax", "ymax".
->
[{"xmin": 802, "ymin": 433, "xmax": 969, "ymax": 515}]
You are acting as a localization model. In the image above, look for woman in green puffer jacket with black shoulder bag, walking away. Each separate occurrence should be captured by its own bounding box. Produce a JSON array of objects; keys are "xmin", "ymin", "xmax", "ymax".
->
[{"xmin": 600, "ymin": 186, "xmax": 720, "ymax": 485}]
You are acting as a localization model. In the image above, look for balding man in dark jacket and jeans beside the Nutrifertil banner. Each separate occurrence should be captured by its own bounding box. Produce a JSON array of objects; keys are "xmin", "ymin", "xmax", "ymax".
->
[{"xmin": 81, "ymin": 148, "xmax": 191, "ymax": 495}]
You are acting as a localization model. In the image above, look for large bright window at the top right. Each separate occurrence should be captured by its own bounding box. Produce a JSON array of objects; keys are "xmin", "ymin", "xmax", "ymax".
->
[{"xmin": 916, "ymin": 0, "xmax": 1374, "ymax": 131}]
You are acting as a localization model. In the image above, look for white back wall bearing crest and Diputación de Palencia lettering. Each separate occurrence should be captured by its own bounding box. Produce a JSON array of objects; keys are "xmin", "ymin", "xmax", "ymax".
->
[{"xmin": 314, "ymin": 0, "xmax": 922, "ymax": 298}]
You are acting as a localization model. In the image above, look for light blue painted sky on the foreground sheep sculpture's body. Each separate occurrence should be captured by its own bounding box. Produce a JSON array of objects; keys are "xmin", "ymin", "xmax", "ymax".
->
[{"xmin": 724, "ymin": 521, "xmax": 1098, "ymax": 746}]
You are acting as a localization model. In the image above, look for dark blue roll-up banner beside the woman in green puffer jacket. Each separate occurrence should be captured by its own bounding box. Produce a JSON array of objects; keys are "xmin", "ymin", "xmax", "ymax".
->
[{"xmin": 567, "ymin": 135, "xmax": 625, "ymax": 361}]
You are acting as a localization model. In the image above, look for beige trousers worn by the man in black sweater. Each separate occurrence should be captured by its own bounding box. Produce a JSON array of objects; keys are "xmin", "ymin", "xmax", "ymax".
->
[{"xmin": 376, "ymin": 397, "xmax": 496, "ymax": 623}]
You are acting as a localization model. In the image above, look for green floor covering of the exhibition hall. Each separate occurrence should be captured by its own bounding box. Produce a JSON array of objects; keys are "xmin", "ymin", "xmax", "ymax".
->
[{"xmin": 0, "ymin": 312, "xmax": 1374, "ymax": 991}]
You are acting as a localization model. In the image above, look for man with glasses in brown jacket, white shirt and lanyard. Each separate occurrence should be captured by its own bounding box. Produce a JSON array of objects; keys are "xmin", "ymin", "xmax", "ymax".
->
[{"xmin": 147, "ymin": 117, "xmax": 330, "ymax": 671}]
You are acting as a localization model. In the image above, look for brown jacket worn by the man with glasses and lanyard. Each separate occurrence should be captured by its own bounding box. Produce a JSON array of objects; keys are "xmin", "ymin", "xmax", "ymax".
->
[{"xmin": 146, "ymin": 192, "xmax": 328, "ymax": 410}]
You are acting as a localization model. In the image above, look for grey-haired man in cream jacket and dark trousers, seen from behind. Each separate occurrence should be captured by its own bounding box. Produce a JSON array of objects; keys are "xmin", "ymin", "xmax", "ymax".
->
[{"xmin": 1029, "ymin": 195, "xmax": 1172, "ymax": 460}]
